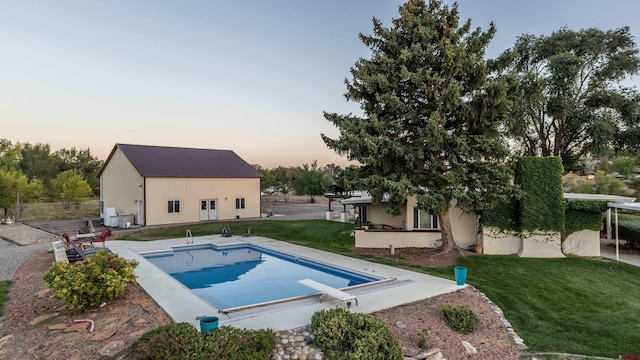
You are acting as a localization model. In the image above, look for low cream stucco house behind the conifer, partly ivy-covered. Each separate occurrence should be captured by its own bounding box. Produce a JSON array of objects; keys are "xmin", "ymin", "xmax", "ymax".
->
[{"xmin": 341, "ymin": 193, "xmax": 635, "ymax": 257}]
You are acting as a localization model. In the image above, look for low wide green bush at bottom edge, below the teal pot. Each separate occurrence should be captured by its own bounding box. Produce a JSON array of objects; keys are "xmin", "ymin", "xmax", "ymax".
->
[{"xmin": 124, "ymin": 322, "xmax": 275, "ymax": 360}]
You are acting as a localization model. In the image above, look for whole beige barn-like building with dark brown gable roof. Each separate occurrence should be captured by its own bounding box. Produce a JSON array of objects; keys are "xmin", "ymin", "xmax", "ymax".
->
[{"xmin": 98, "ymin": 144, "xmax": 262, "ymax": 227}]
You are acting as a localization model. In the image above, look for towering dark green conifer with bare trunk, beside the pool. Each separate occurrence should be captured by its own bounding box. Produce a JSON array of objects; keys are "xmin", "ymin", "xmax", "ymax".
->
[{"xmin": 322, "ymin": 0, "xmax": 510, "ymax": 252}]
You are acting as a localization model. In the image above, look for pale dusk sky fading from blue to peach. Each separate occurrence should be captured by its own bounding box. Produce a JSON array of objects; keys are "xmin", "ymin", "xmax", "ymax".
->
[{"xmin": 0, "ymin": 0, "xmax": 640, "ymax": 168}]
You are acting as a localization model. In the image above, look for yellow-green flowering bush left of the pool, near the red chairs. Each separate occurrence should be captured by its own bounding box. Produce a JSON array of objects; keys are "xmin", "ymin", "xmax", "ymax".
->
[{"xmin": 43, "ymin": 250, "xmax": 138, "ymax": 311}]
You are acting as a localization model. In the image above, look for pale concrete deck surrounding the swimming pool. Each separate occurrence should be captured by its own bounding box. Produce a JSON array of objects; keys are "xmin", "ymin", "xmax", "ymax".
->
[{"xmin": 107, "ymin": 235, "xmax": 464, "ymax": 330}]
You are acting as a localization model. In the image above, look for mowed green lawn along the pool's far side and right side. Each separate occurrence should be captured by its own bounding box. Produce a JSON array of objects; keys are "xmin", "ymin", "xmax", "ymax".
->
[{"xmin": 122, "ymin": 220, "xmax": 640, "ymax": 357}]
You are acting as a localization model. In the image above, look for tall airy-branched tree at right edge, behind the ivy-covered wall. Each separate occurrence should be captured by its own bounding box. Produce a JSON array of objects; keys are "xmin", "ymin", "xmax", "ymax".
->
[{"xmin": 501, "ymin": 27, "xmax": 640, "ymax": 170}]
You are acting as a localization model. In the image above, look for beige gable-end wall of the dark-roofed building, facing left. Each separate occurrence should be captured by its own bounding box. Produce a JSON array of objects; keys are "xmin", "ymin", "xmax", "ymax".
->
[{"xmin": 100, "ymin": 149, "xmax": 144, "ymax": 224}]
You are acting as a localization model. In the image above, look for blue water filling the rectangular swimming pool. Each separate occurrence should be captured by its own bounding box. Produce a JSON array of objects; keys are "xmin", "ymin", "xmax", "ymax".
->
[{"xmin": 141, "ymin": 245, "xmax": 381, "ymax": 310}]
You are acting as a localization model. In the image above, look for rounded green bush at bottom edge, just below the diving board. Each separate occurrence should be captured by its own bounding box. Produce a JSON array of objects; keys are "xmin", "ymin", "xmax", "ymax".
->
[{"xmin": 311, "ymin": 309, "xmax": 402, "ymax": 360}]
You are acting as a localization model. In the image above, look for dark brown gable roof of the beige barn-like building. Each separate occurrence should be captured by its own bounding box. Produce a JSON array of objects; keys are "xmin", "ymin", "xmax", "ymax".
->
[{"xmin": 98, "ymin": 144, "xmax": 262, "ymax": 178}]
